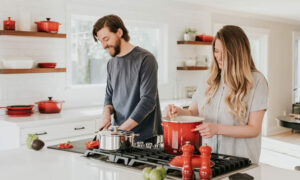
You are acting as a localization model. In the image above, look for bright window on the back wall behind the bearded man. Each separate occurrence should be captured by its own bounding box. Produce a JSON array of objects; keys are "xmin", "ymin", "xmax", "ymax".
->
[{"xmin": 71, "ymin": 16, "xmax": 165, "ymax": 85}]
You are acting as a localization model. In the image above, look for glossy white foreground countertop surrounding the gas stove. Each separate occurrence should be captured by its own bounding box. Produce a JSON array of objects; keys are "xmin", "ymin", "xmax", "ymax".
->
[{"xmin": 0, "ymin": 147, "xmax": 300, "ymax": 180}]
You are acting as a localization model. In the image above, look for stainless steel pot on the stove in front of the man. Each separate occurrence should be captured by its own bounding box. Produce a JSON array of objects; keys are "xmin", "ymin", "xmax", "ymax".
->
[{"xmin": 98, "ymin": 127, "xmax": 139, "ymax": 151}]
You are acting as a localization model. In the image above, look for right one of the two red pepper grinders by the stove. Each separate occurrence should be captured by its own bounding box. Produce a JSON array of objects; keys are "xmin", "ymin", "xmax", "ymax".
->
[{"xmin": 199, "ymin": 144, "xmax": 212, "ymax": 180}]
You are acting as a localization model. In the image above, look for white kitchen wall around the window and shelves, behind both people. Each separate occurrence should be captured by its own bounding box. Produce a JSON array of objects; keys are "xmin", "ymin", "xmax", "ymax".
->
[{"xmin": 0, "ymin": 0, "xmax": 300, "ymax": 134}]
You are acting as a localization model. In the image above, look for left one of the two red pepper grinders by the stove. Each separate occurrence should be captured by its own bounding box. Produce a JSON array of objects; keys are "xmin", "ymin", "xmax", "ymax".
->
[{"xmin": 181, "ymin": 141, "xmax": 194, "ymax": 180}]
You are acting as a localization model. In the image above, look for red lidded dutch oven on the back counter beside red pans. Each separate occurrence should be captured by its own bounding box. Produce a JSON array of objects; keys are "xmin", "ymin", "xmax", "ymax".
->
[{"xmin": 36, "ymin": 97, "xmax": 64, "ymax": 113}]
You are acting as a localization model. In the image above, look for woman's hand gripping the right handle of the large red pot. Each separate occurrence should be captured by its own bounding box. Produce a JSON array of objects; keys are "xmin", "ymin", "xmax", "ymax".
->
[{"xmin": 193, "ymin": 123, "xmax": 219, "ymax": 138}]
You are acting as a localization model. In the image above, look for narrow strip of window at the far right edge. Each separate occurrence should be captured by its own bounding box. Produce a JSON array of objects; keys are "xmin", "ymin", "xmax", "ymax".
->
[{"xmin": 294, "ymin": 33, "xmax": 300, "ymax": 103}]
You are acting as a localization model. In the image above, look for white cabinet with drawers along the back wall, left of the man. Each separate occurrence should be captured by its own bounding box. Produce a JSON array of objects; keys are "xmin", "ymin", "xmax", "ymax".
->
[{"xmin": 0, "ymin": 107, "xmax": 102, "ymax": 150}]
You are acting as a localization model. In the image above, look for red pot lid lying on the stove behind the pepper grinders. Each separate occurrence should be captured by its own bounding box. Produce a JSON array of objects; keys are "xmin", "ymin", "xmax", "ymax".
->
[{"xmin": 169, "ymin": 155, "xmax": 215, "ymax": 169}]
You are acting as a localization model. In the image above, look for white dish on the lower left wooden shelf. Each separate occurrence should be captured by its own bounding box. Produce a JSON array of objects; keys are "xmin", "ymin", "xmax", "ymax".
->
[{"xmin": 2, "ymin": 59, "xmax": 34, "ymax": 69}]
